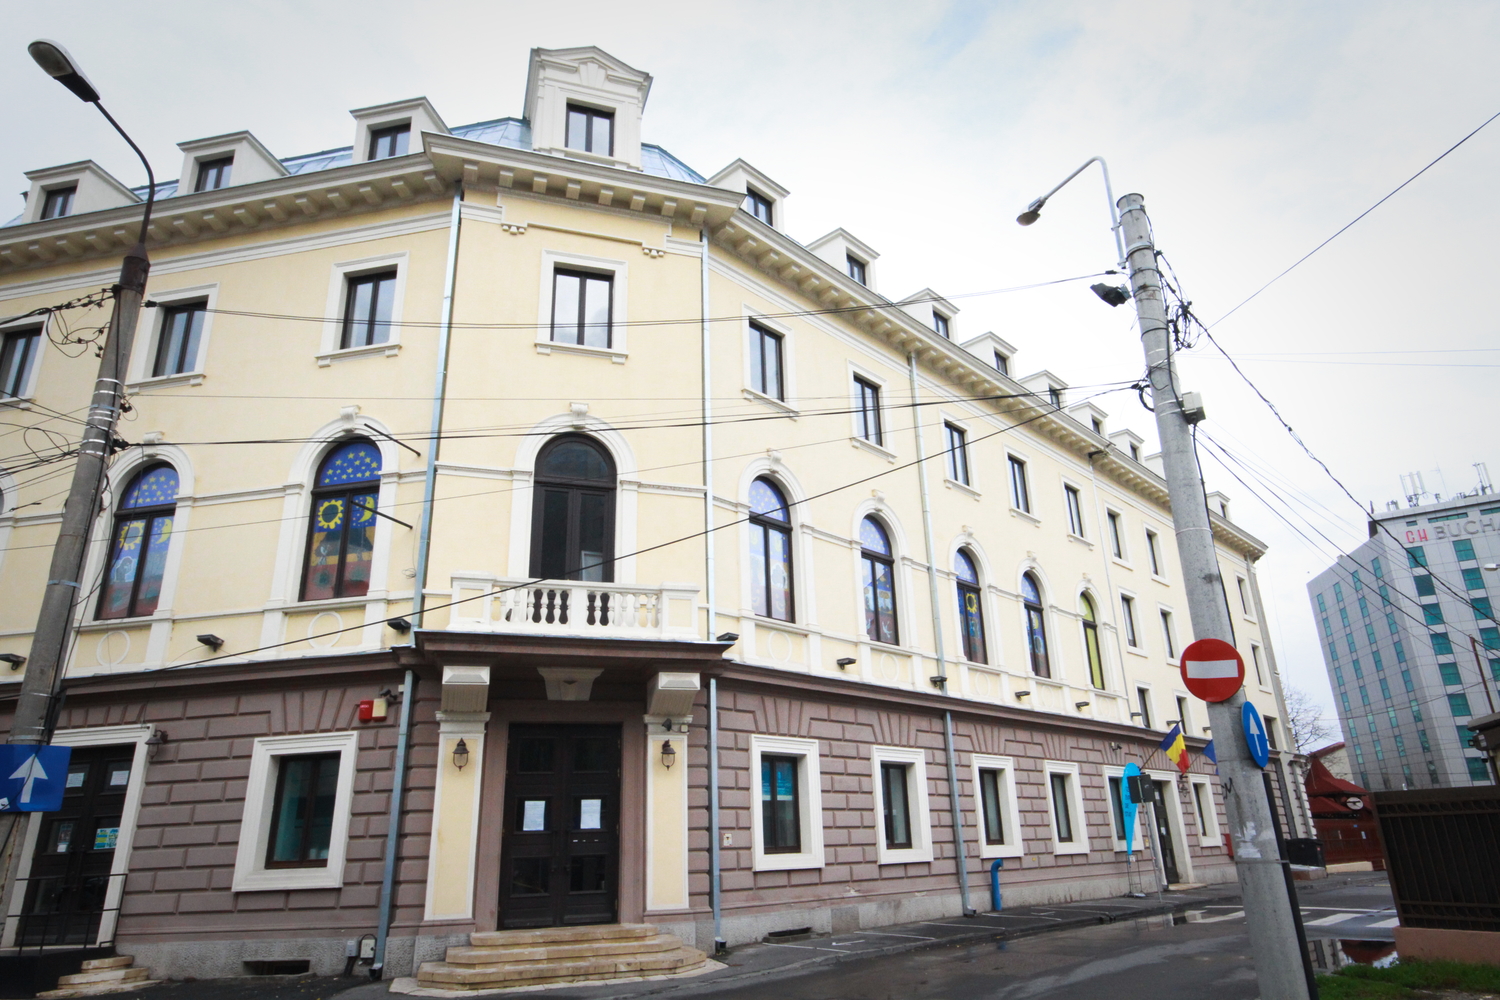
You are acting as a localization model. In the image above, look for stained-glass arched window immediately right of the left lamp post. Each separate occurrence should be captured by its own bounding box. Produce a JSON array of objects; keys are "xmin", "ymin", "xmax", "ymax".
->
[{"xmin": 99, "ymin": 465, "xmax": 177, "ymax": 618}]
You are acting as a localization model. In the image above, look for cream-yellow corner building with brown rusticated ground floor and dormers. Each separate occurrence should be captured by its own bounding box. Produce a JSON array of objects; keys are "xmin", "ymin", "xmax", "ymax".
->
[{"xmin": 0, "ymin": 48, "xmax": 1307, "ymax": 976}]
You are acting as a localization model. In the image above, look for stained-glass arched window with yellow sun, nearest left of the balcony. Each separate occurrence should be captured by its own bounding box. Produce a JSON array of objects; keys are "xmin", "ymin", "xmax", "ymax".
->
[{"xmin": 302, "ymin": 439, "xmax": 381, "ymax": 601}]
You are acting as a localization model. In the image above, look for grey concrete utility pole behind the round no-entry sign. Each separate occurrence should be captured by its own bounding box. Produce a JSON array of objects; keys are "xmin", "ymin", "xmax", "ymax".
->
[{"xmin": 1119, "ymin": 195, "xmax": 1311, "ymax": 1000}]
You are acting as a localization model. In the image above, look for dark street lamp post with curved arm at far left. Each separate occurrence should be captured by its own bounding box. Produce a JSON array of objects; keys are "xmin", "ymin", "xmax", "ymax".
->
[{"xmin": 0, "ymin": 39, "xmax": 156, "ymax": 919}]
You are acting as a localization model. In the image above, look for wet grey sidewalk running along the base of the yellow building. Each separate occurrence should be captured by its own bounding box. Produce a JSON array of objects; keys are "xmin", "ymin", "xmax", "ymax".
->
[{"xmin": 70, "ymin": 871, "xmax": 1386, "ymax": 1000}]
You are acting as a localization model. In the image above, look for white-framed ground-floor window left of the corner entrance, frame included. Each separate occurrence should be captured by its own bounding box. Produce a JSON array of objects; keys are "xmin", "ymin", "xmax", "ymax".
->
[{"xmin": 233, "ymin": 733, "xmax": 359, "ymax": 892}]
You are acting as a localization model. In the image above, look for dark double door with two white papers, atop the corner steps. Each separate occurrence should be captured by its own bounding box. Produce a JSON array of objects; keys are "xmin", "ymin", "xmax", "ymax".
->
[{"xmin": 500, "ymin": 726, "xmax": 620, "ymax": 928}]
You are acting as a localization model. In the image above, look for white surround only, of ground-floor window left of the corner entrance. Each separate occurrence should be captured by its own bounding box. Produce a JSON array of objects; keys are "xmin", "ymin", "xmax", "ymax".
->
[{"xmin": 231, "ymin": 732, "xmax": 360, "ymax": 892}]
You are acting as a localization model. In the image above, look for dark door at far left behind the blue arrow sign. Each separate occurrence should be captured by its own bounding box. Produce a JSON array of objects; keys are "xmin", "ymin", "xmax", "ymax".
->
[{"xmin": 15, "ymin": 745, "xmax": 135, "ymax": 946}]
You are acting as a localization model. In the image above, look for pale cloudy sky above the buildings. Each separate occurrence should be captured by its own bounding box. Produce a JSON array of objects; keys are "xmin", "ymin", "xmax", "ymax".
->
[{"xmin": 0, "ymin": 0, "xmax": 1500, "ymax": 727}]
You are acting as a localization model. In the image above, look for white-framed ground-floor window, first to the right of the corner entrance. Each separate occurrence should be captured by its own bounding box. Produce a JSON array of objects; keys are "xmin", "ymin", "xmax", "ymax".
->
[{"xmin": 750, "ymin": 733, "xmax": 824, "ymax": 871}]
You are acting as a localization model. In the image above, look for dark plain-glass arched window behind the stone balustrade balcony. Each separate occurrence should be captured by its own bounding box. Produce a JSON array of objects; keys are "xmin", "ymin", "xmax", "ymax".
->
[{"xmin": 531, "ymin": 435, "xmax": 615, "ymax": 583}]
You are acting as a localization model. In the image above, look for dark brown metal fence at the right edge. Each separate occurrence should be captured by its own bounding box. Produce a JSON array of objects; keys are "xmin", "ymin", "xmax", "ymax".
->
[{"xmin": 1374, "ymin": 786, "xmax": 1500, "ymax": 931}]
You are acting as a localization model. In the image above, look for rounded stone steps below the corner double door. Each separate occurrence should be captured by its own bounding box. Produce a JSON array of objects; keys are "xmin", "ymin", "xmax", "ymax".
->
[{"xmin": 417, "ymin": 924, "xmax": 708, "ymax": 990}]
